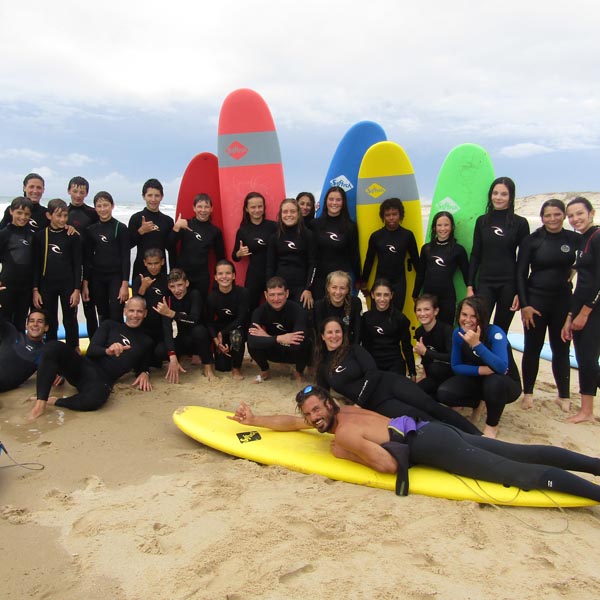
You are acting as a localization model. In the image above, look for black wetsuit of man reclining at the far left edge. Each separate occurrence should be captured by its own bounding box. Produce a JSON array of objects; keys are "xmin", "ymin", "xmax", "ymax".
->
[{"xmin": 0, "ymin": 317, "xmax": 44, "ymax": 392}]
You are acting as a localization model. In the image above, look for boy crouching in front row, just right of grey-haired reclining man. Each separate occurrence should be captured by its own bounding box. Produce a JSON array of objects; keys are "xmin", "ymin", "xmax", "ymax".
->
[{"xmin": 154, "ymin": 269, "xmax": 215, "ymax": 383}]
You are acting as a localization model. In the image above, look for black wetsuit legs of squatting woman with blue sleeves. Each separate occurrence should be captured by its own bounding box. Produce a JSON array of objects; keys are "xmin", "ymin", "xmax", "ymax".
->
[{"xmin": 437, "ymin": 373, "xmax": 521, "ymax": 427}]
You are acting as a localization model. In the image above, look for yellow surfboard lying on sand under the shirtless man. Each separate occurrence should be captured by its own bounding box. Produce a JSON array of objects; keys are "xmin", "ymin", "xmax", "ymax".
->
[{"xmin": 173, "ymin": 406, "xmax": 596, "ymax": 507}]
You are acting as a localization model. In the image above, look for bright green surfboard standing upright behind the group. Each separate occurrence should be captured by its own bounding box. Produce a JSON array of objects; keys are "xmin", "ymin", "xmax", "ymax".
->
[{"xmin": 426, "ymin": 144, "xmax": 494, "ymax": 300}]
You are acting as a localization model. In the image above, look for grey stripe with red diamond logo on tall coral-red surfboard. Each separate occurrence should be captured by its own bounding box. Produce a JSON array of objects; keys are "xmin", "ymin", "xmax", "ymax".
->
[{"xmin": 219, "ymin": 131, "xmax": 281, "ymax": 167}]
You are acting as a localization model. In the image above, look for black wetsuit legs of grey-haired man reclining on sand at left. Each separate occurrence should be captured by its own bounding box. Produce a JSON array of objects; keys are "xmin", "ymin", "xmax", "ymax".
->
[{"xmin": 37, "ymin": 341, "xmax": 111, "ymax": 411}]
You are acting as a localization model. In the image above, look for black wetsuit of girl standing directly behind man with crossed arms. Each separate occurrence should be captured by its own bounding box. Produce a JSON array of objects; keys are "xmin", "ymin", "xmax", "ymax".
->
[{"xmin": 267, "ymin": 226, "xmax": 317, "ymax": 302}]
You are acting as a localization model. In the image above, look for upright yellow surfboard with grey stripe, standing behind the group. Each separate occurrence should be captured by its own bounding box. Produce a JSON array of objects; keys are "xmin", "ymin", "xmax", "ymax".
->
[{"xmin": 356, "ymin": 142, "xmax": 423, "ymax": 332}]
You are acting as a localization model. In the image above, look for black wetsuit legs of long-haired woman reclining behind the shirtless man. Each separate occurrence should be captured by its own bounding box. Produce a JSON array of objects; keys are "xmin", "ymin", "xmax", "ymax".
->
[{"xmin": 365, "ymin": 372, "xmax": 481, "ymax": 435}]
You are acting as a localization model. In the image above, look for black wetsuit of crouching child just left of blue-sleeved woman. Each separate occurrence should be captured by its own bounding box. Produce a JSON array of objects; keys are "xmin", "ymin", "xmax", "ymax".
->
[{"xmin": 415, "ymin": 321, "xmax": 454, "ymax": 398}]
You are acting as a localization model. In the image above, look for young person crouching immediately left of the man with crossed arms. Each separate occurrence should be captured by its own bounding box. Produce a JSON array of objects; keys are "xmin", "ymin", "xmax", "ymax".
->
[{"xmin": 206, "ymin": 259, "xmax": 249, "ymax": 380}]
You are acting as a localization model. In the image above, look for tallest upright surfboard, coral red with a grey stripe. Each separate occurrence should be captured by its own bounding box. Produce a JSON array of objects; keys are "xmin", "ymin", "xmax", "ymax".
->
[{"xmin": 218, "ymin": 89, "xmax": 285, "ymax": 285}]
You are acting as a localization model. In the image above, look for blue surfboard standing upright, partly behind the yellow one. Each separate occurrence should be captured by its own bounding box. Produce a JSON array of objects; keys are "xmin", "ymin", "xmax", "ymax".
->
[{"xmin": 316, "ymin": 121, "xmax": 387, "ymax": 221}]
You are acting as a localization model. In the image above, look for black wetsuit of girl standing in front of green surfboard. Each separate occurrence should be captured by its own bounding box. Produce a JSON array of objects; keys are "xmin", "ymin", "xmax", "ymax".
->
[{"xmin": 413, "ymin": 240, "xmax": 469, "ymax": 325}]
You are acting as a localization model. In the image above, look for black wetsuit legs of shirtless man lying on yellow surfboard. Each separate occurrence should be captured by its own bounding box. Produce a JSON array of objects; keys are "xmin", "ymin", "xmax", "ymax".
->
[{"xmin": 410, "ymin": 423, "xmax": 600, "ymax": 502}]
